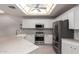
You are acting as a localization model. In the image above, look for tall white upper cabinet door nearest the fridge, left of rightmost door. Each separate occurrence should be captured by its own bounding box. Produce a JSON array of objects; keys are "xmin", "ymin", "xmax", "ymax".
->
[{"xmin": 68, "ymin": 9, "xmax": 75, "ymax": 29}]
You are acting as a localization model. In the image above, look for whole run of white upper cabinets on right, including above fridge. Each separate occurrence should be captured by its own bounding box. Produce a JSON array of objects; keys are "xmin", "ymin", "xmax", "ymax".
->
[{"xmin": 56, "ymin": 5, "xmax": 79, "ymax": 29}]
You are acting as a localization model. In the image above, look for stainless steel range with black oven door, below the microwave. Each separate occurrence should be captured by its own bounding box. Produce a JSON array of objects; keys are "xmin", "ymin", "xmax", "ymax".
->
[{"xmin": 35, "ymin": 32, "xmax": 44, "ymax": 44}]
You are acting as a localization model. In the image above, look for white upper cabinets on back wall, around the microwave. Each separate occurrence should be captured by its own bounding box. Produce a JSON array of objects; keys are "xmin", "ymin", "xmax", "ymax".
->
[{"xmin": 22, "ymin": 18, "xmax": 53, "ymax": 28}]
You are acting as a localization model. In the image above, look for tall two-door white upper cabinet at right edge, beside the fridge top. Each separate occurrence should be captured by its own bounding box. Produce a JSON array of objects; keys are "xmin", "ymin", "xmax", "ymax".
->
[{"xmin": 67, "ymin": 5, "xmax": 79, "ymax": 29}]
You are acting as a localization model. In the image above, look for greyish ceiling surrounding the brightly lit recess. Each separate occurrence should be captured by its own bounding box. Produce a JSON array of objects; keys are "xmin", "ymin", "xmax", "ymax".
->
[{"xmin": 0, "ymin": 4, "xmax": 75, "ymax": 18}]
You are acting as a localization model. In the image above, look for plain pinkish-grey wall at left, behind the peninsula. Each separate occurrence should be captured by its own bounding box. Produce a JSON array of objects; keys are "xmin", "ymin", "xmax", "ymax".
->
[{"xmin": 0, "ymin": 15, "xmax": 20, "ymax": 40}]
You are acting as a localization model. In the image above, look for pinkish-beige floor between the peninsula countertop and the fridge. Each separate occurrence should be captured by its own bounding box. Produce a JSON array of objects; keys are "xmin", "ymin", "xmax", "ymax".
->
[{"xmin": 29, "ymin": 45, "xmax": 56, "ymax": 54}]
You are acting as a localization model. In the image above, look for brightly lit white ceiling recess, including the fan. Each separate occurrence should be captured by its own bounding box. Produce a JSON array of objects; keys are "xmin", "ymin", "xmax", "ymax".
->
[{"xmin": 17, "ymin": 4, "xmax": 56, "ymax": 15}]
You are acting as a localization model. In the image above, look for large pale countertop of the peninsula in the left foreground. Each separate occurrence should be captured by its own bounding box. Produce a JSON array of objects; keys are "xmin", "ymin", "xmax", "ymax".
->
[{"xmin": 0, "ymin": 36, "xmax": 39, "ymax": 54}]
